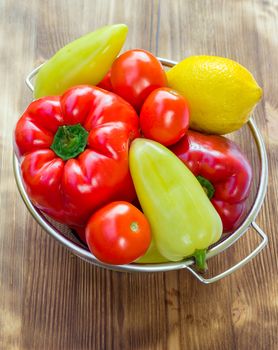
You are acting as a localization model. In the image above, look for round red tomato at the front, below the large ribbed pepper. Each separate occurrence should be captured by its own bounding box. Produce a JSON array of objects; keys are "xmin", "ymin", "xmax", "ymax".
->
[{"xmin": 86, "ymin": 201, "xmax": 151, "ymax": 265}]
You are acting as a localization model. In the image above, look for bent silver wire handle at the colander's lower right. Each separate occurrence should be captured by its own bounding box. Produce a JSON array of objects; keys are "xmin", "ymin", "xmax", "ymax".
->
[{"xmin": 186, "ymin": 221, "xmax": 268, "ymax": 284}]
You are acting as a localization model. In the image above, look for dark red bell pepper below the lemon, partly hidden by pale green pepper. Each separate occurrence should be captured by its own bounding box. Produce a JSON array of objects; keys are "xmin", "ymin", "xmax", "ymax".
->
[{"xmin": 171, "ymin": 130, "xmax": 252, "ymax": 232}]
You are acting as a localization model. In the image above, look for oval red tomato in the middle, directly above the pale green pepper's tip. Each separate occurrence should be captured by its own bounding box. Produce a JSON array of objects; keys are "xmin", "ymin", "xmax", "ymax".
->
[{"xmin": 140, "ymin": 88, "xmax": 189, "ymax": 146}]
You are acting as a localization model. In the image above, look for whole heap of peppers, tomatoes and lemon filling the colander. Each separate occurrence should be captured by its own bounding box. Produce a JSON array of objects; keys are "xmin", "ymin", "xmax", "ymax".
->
[{"xmin": 15, "ymin": 24, "xmax": 262, "ymax": 269}]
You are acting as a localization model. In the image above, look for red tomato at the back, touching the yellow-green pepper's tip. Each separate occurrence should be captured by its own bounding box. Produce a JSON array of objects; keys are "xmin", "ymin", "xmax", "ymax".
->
[{"xmin": 111, "ymin": 49, "xmax": 167, "ymax": 111}]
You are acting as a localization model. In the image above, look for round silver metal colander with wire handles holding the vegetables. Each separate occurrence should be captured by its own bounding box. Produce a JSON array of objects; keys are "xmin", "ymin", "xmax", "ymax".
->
[{"xmin": 13, "ymin": 58, "xmax": 268, "ymax": 284}]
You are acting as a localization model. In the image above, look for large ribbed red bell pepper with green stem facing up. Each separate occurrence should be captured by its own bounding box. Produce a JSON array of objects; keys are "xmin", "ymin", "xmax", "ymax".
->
[{"xmin": 15, "ymin": 86, "xmax": 139, "ymax": 227}]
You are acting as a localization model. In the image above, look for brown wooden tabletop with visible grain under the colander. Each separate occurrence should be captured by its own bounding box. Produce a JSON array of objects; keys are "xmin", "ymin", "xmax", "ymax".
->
[{"xmin": 0, "ymin": 0, "xmax": 278, "ymax": 350}]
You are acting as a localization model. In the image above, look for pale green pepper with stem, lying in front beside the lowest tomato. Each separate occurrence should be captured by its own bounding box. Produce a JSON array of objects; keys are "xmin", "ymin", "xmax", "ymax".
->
[{"xmin": 129, "ymin": 138, "xmax": 222, "ymax": 269}]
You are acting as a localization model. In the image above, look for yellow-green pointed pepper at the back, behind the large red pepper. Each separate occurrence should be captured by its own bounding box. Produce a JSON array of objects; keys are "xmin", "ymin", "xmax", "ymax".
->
[{"xmin": 34, "ymin": 24, "xmax": 128, "ymax": 98}]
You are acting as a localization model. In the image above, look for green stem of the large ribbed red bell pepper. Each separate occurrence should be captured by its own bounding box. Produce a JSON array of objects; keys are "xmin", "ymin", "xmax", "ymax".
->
[{"xmin": 50, "ymin": 124, "xmax": 89, "ymax": 160}]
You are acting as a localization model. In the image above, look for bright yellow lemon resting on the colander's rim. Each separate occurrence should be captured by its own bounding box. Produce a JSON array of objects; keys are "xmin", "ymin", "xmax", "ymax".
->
[{"xmin": 167, "ymin": 56, "xmax": 262, "ymax": 134}]
